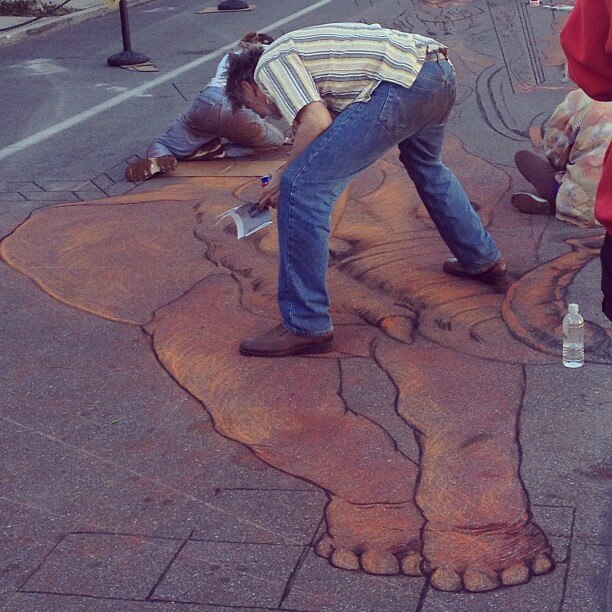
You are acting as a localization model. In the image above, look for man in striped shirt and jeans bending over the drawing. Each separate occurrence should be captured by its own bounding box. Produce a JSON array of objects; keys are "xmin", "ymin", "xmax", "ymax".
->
[{"xmin": 226, "ymin": 23, "xmax": 509, "ymax": 357}]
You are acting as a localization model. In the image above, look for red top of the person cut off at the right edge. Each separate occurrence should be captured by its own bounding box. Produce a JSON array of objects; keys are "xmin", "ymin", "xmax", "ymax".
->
[{"xmin": 561, "ymin": 0, "xmax": 612, "ymax": 234}]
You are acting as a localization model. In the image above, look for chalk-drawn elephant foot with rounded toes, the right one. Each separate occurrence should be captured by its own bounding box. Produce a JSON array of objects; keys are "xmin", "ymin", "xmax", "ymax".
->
[{"xmin": 423, "ymin": 523, "xmax": 554, "ymax": 592}]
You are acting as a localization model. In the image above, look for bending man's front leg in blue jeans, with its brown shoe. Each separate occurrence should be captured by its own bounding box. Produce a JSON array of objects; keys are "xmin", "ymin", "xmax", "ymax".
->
[{"xmin": 240, "ymin": 82, "xmax": 407, "ymax": 357}]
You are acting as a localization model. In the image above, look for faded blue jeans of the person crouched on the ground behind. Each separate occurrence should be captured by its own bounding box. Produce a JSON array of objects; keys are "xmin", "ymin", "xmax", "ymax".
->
[{"xmin": 147, "ymin": 87, "xmax": 285, "ymax": 159}]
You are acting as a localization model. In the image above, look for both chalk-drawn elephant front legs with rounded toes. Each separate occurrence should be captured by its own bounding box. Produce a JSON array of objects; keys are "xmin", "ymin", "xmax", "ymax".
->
[{"xmin": 146, "ymin": 274, "xmax": 552, "ymax": 591}]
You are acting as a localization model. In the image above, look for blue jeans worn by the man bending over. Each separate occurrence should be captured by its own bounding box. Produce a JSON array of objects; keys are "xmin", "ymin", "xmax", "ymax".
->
[{"xmin": 278, "ymin": 59, "xmax": 500, "ymax": 336}]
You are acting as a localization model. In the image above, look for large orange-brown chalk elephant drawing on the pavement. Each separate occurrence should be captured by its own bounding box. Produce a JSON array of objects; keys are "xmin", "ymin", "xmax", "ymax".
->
[{"xmin": 1, "ymin": 131, "xmax": 604, "ymax": 591}]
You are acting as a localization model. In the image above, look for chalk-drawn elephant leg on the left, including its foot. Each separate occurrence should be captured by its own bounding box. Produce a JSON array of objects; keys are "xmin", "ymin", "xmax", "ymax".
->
[{"xmin": 146, "ymin": 274, "xmax": 423, "ymax": 574}]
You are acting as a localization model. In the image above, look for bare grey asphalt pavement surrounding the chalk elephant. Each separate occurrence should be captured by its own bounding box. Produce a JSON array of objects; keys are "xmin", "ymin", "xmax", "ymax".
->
[{"xmin": 0, "ymin": 0, "xmax": 612, "ymax": 612}]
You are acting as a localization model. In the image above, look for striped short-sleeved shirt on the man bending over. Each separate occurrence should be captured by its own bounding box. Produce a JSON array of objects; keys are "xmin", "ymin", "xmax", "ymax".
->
[{"xmin": 255, "ymin": 23, "xmax": 445, "ymax": 125}]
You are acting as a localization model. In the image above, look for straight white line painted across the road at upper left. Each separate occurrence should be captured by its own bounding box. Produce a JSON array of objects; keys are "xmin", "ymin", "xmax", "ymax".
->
[{"xmin": 0, "ymin": 0, "xmax": 333, "ymax": 160}]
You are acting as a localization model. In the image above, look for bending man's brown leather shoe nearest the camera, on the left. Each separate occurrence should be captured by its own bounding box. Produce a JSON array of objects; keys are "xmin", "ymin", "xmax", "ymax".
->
[{"xmin": 240, "ymin": 324, "xmax": 334, "ymax": 357}]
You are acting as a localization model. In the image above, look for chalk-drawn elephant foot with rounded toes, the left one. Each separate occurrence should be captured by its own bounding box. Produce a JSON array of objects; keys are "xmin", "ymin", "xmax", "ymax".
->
[{"xmin": 315, "ymin": 497, "xmax": 423, "ymax": 576}]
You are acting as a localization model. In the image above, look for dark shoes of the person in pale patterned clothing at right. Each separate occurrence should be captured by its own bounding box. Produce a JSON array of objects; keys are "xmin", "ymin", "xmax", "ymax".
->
[{"xmin": 511, "ymin": 151, "xmax": 559, "ymax": 215}]
